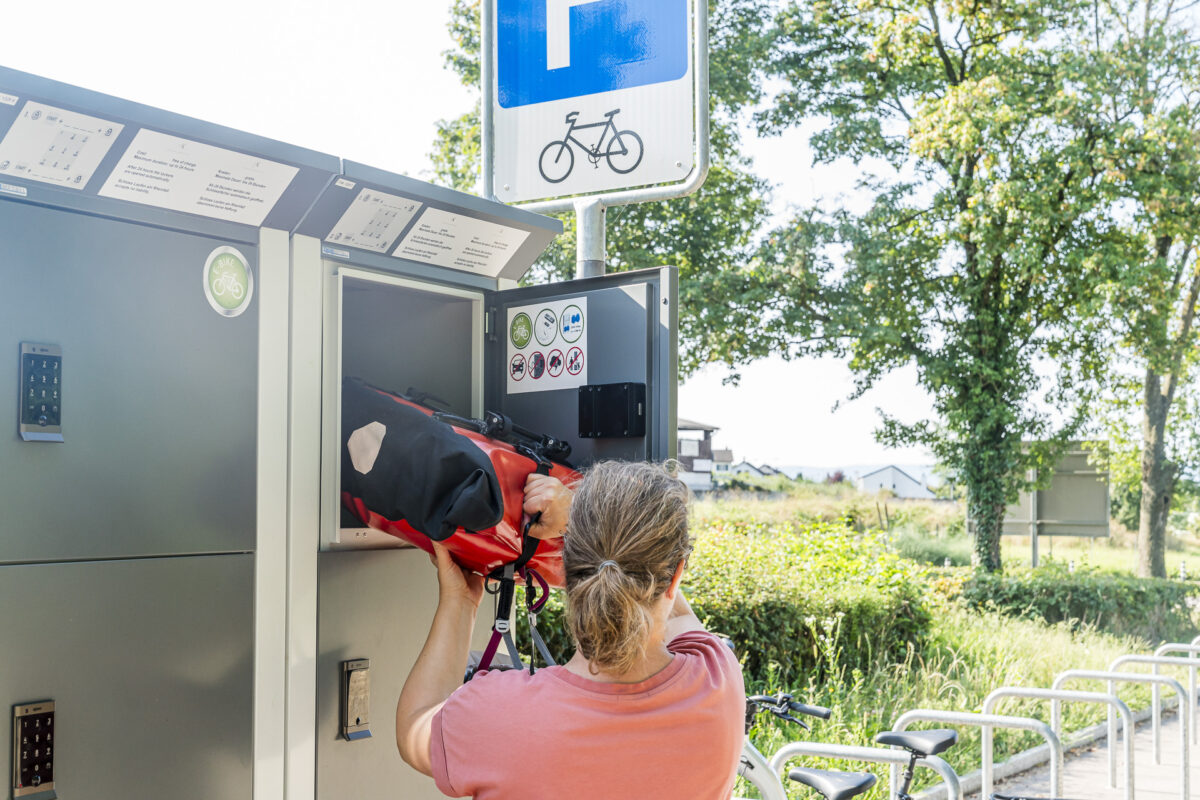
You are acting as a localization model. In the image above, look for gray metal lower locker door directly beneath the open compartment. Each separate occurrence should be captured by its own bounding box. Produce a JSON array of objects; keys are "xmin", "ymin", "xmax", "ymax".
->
[{"xmin": 317, "ymin": 551, "xmax": 487, "ymax": 800}]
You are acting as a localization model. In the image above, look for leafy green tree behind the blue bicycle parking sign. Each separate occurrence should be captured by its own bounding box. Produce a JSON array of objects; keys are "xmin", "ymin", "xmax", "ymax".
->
[{"xmin": 433, "ymin": 0, "xmax": 793, "ymax": 374}]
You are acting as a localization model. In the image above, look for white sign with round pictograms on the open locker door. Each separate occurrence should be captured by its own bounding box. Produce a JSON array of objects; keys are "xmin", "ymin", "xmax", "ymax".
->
[{"xmin": 508, "ymin": 297, "xmax": 588, "ymax": 395}]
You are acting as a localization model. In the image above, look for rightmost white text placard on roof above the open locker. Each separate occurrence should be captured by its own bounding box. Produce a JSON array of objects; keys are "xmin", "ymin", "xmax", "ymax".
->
[{"xmin": 392, "ymin": 209, "xmax": 529, "ymax": 277}]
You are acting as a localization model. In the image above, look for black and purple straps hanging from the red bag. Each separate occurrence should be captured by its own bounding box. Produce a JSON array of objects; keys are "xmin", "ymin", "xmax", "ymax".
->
[{"xmin": 463, "ymin": 455, "xmax": 554, "ymax": 682}]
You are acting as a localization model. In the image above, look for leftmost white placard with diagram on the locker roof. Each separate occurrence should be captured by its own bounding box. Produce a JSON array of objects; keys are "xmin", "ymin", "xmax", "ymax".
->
[{"xmin": 0, "ymin": 101, "xmax": 125, "ymax": 190}]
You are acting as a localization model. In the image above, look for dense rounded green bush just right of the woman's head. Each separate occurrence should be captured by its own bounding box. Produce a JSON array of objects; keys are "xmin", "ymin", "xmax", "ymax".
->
[{"xmin": 517, "ymin": 523, "xmax": 930, "ymax": 682}]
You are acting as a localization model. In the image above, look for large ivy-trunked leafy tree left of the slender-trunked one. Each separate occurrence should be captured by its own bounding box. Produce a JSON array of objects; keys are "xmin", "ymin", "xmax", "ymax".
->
[{"xmin": 761, "ymin": 0, "xmax": 1111, "ymax": 571}]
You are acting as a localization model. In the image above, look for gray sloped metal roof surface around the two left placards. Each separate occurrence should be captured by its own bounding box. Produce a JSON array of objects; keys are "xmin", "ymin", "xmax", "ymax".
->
[{"xmin": 0, "ymin": 67, "xmax": 341, "ymax": 235}]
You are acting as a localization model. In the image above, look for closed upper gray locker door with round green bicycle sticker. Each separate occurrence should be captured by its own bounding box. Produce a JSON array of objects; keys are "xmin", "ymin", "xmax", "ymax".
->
[{"xmin": 0, "ymin": 203, "xmax": 258, "ymax": 563}]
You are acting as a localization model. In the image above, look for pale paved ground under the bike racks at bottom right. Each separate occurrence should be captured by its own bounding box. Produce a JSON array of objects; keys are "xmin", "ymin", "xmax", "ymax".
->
[{"xmin": 967, "ymin": 715, "xmax": 1200, "ymax": 800}]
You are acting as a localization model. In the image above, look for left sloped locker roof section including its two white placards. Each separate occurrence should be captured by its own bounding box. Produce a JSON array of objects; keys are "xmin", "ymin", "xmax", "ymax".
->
[{"xmin": 0, "ymin": 67, "xmax": 341, "ymax": 237}]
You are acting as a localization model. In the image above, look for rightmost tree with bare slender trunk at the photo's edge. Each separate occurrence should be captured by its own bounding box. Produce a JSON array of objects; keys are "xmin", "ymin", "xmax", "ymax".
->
[{"xmin": 1091, "ymin": 0, "xmax": 1200, "ymax": 577}]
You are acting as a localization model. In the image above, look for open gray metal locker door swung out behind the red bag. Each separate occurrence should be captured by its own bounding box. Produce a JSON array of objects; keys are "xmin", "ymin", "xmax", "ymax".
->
[{"xmin": 487, "ymin": 270, "xmax": 677, "ymax": 467}]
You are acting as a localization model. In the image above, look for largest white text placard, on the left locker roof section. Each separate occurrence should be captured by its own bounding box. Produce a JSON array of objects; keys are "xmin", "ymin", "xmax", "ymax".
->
[{"xmin": 100, "ymin": 130, "xmax": 300, "ymax": 225}]
